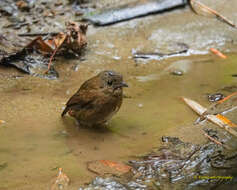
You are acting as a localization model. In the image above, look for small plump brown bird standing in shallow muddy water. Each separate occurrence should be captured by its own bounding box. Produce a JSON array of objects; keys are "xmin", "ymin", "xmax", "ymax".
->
[{"xmin": 62, "ymin": 71, "xmax": 128, "ymax": 126}]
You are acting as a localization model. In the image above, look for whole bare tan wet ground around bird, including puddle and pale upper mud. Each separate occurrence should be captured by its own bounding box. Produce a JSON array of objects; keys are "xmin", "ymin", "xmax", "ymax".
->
[{"xmin": 0, "ymin": 1, "xmax": 237, "ymax": 190}]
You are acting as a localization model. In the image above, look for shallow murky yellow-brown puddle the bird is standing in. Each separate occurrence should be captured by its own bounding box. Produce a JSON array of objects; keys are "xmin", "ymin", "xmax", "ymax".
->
[{"xmin": 0, "ymin": 52, "xmax": 237, "ymax": 189}]
